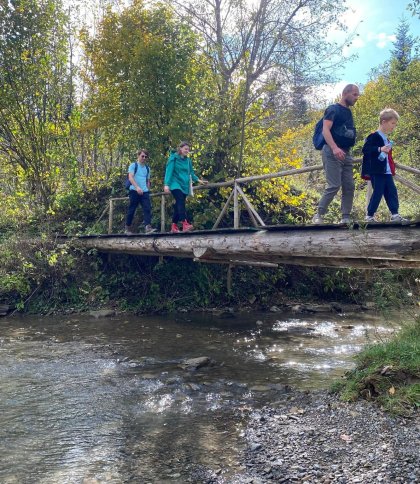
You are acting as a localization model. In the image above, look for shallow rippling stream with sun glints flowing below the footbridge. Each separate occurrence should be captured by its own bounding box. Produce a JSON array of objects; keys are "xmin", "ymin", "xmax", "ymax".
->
[{"xmin": 0, "ymin": 313, "xmax": 399, "ymax": 484}]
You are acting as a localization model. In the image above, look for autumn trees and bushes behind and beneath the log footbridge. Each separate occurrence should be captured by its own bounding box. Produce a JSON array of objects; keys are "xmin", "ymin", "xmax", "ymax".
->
[{"xmin": 0, "ymin": 0, "xmax": 420, "ymax": 313}]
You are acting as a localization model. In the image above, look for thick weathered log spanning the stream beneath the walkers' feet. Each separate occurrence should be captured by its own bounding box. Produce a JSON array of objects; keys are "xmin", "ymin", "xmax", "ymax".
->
[{"xmin": 74, "ymin": 222, "xmax": 420, "ymax": 269}]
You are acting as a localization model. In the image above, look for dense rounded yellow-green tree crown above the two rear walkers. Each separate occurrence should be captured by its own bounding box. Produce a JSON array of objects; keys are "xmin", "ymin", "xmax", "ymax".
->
[{"xmin": 83, "ymin": 1, "xmax": 211, "ymax": 172}]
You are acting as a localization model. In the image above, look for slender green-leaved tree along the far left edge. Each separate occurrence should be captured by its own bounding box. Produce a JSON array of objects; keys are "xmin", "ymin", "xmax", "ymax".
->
[{"xmin": 0, "ymin": 0, "xmax": 72, "ymax": 210}]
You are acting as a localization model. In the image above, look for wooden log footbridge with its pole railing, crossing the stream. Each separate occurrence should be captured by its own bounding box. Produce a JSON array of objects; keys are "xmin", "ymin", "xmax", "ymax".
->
[{"xmin": 79, "ymin": 165, "xmax": 420, "ymax": 269}]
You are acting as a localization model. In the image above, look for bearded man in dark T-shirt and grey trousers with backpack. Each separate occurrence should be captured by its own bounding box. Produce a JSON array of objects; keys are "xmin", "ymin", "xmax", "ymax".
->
[{"xmin": 312, "ymin": 84, "xmax": 360, "ymax": 224}]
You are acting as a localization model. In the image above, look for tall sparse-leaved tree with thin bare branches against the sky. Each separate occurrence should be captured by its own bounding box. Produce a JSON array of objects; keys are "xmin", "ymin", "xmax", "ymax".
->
[{"xmin": 169, "ymin": 0, "xmax": 352, "ymax": 178}]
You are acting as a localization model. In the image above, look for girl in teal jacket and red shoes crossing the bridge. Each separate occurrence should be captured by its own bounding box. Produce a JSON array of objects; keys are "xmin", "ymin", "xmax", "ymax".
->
[{"xmin": 163, "ymin": 142, "xmax": 207, "ymax": 233}]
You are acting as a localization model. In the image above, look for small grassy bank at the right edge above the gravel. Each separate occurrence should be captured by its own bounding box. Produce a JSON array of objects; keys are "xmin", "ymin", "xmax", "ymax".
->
[{"xmin": 333, "ymin": 317, "xmax": 420, "ymax": 416}]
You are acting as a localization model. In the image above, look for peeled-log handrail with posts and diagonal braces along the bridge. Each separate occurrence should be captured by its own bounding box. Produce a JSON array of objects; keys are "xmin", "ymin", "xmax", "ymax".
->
[{"xmin": 105, "ymin": 159, "xmax": 420, "ymax": 234}]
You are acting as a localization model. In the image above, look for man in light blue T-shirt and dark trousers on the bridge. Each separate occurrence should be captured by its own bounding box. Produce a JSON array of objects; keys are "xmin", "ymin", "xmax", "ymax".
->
[{"xmin": 125, "ymin": 149, "xmax": 156, "ymax": 235}]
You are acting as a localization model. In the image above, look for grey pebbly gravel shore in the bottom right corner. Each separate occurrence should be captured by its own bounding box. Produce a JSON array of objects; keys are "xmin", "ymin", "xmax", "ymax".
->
[{"xmin": 215, "ymin": 392, "xmax": 420, "ymax": 484}]
